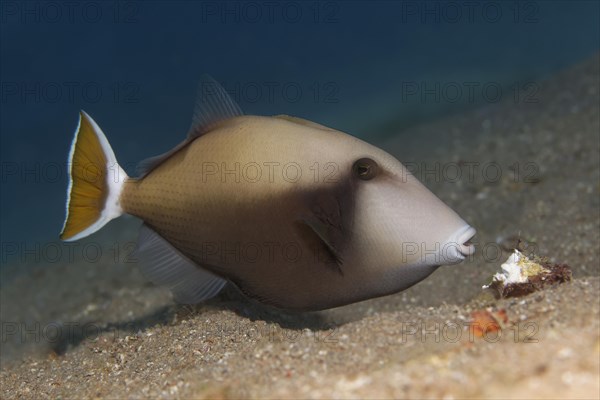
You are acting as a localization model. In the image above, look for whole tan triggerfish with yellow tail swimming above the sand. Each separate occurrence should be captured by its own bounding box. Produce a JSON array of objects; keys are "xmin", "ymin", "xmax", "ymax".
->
[{"xmin": 60, "ymin": 77, "xmax": 475, "ymax": 310}]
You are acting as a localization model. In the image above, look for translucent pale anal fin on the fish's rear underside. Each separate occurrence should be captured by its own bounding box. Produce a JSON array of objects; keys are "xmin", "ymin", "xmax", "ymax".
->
[{"xmin": 136, "ymin": 224, "xmax": 227, "ymax": 304}]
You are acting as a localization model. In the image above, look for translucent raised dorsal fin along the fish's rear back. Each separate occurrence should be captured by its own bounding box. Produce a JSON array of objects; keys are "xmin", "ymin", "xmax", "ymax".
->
[{"xmin": 137, "ymin": 74, "xmax": 244, "ymax": 178}]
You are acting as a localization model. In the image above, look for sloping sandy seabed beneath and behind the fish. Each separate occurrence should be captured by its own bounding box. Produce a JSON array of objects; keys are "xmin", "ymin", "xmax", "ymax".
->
[{"xmin": 0, "ymin": 55, "xmax": 600, "ymax": 399}]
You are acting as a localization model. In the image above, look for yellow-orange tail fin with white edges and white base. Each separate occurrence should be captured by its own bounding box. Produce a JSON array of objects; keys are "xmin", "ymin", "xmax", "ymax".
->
[{"xmin": 60, "ymin": 111, "xmax": 127, "ymax": 241}]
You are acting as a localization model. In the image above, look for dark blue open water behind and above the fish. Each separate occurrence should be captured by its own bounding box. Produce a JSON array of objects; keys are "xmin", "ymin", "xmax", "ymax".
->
[{"xmin": 0, "ymin": 1, "xmax": 600, "ymax": 264}]
